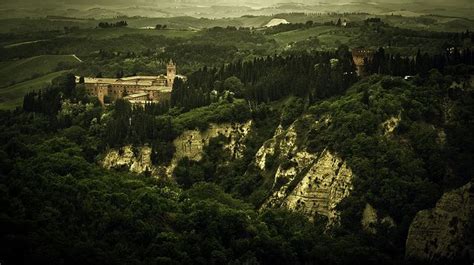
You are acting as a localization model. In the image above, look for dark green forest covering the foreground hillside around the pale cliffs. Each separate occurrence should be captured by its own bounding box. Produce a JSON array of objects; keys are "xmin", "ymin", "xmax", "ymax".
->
[{"xmin": 1, "ymin": 52, "xmax": 474, "ymax": 264}]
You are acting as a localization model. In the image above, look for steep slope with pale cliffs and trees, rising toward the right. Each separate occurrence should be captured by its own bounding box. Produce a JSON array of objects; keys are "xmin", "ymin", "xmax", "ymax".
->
[{"xmin": 98, "ymin": 71, "xmax": 474, "ymax": 259}]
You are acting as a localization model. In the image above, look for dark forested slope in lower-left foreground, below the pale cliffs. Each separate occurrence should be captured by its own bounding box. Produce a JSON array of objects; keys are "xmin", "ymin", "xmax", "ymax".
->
[{"xmin": 0, "ymin": 113, "xmax": 392, "ymax": 264}]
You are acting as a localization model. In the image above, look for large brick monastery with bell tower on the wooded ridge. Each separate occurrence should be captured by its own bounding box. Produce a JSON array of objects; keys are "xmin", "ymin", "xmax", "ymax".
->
[{"xmin": 76, "ymin": 60, "xmax": 186, "ymax": 104}]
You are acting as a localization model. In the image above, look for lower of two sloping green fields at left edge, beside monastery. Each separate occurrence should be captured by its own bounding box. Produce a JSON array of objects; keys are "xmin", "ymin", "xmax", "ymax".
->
[{"xmin": 0, "ymin": 71, "xmax": 67, "ymax": 109}]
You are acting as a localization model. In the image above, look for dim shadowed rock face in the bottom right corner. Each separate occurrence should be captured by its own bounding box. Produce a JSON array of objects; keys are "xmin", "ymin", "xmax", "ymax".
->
[{"xmin": 406, "ymin": 183, "xmax": 474, "ymax": 261}]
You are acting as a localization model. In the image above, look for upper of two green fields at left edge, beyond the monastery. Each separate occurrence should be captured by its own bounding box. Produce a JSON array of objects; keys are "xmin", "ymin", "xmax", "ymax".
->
[{"xmin": 0, "ymin": 55, "xmax": 79, "ymax": 88}]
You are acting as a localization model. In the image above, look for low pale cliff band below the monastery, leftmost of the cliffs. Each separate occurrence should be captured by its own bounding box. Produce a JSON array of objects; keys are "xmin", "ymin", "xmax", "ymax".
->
[{"xmin": 101, "ymin": 121, "xmax": 252, "ymax": 177}]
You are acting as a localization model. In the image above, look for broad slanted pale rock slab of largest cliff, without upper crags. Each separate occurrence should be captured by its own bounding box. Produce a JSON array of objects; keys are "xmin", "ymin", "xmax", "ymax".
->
[{"xmin": 262, "ymin": 146, "xmax": 353, "ymax": 224}]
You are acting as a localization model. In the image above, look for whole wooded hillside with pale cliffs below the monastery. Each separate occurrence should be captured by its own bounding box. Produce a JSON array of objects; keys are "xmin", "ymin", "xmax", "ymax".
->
[{"xmin": 0, "ymin": 62, "xmax": 474, "ymax": 264}]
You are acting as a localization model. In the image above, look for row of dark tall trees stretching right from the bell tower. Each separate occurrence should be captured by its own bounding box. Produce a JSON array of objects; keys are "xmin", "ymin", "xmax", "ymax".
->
[{"xmin": 171, "ymin": 46, "xmax": 357, "ymax": 109}]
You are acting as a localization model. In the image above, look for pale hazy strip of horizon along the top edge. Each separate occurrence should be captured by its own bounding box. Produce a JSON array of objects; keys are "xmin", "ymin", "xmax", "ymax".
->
[{"xmin": 0, "ymin": 0, "xmax": 474, "ymax": 19}]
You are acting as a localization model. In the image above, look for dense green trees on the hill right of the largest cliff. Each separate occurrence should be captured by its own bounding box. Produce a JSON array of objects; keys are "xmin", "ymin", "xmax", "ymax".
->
[{"xmin": 300, "ymin": 71, "xmax": 473, "ymax": 255}]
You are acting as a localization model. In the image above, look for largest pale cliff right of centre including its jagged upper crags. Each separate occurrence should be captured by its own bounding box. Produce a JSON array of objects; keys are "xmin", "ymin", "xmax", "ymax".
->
[{"xmin": 255, "ymin": 118, "xmax": 353, "ymax": 224}]
